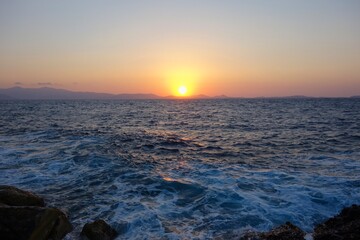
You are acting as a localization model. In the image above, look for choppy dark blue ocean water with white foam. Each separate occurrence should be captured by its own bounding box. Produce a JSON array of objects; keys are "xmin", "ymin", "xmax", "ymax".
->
[{"xmin": 0, "ymin": 99, "xmax": 360, "ymax": 239}]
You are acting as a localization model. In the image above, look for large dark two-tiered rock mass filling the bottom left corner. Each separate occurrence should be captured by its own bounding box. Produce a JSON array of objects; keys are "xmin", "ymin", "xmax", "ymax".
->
[{"xmin": 0, "ymin": 186, "xmax": 72, "ymax": 240}]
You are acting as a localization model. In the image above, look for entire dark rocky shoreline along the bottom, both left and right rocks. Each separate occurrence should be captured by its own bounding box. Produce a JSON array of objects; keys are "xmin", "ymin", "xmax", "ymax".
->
[{"xmin": 0, "ymin": 186, "xmax": 360, "ymax": 240}]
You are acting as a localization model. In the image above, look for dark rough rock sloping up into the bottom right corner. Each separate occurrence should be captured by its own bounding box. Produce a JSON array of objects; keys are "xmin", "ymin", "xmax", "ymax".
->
[{"xmin": 313, "ymin": 205, "xmax": 360, "ymax": 240}]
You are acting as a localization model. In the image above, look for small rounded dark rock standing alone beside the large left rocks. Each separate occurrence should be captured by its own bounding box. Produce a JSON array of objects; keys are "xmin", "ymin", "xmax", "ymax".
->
[{"xmin": 81, "ymin": 220, "xmax": 117, "ymax": 240}]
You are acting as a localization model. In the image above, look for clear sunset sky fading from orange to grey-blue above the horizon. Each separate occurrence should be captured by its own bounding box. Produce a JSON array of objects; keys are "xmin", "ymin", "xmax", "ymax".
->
[{"xmin": 0, "ymin": 0, "xmax": 360, "ymax": 97}]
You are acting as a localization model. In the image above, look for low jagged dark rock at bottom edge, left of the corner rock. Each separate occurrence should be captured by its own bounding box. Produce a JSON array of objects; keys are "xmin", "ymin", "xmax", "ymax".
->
[{"xmin": 240, "ymin": 222, "xmax": 305, "ymax": 240}]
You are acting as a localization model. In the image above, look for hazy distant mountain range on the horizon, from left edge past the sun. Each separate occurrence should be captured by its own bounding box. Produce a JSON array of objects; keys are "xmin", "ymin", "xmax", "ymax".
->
[{"xmin": 0, "ymin": 87, "xmax": 231, "ymax": 100}]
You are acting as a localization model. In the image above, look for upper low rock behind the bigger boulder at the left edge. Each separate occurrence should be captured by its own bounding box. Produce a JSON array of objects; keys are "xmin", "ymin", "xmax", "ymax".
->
[{"xmin": 0, "ymin": 185, "xmax": 45, "ymax": 207}]
